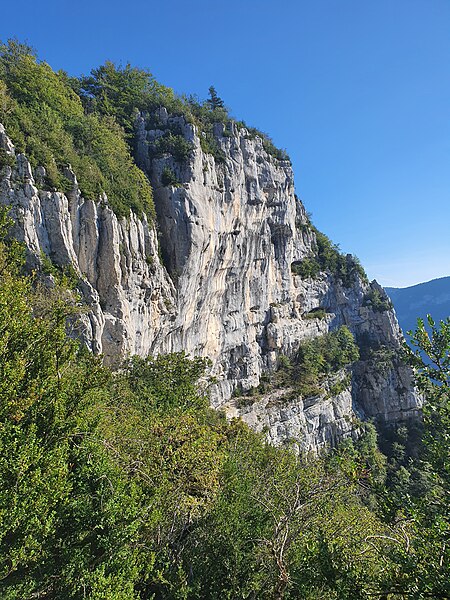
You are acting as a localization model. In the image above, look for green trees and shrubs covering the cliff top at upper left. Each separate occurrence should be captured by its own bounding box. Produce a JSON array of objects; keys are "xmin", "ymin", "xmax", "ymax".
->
[{"xmin": 0, "ymin": 41, "xmax": 292, "ymax": 217}]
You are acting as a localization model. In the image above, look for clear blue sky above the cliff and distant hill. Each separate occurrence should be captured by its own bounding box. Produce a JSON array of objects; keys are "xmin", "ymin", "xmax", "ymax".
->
[{"xmin": 0, "ymin": 0, "xmax": 450, "ymax": 286}]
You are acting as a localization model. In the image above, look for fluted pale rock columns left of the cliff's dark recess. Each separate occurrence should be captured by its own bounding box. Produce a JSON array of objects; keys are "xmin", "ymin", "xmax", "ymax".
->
[{"xmin": 0, "ymin": 127, "xmax": 176, "ymax": 362}]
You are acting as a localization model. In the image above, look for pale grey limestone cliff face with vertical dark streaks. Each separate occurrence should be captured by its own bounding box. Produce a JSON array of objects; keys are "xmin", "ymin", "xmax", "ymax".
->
[{"xmin": 0, "ymin": 119, "xmax": 417, "ymax": 449}]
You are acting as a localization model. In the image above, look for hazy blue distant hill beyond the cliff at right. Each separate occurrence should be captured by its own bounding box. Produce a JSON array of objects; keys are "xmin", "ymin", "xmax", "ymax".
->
[{"xmin": 384, "ymin": 277, "xmax": 450, "ymax": 332}]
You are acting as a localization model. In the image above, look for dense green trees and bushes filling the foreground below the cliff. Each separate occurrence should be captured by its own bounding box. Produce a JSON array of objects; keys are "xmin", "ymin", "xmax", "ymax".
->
[{"xmin": 0, "ymin": 209, "xmax": 450, "ymax": 600}]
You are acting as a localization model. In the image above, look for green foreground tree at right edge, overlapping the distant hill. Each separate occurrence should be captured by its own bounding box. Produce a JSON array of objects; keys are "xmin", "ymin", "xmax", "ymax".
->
[{"xmin": 370, "ymin": 316, "xmax": 450, "ymax": 598}]
